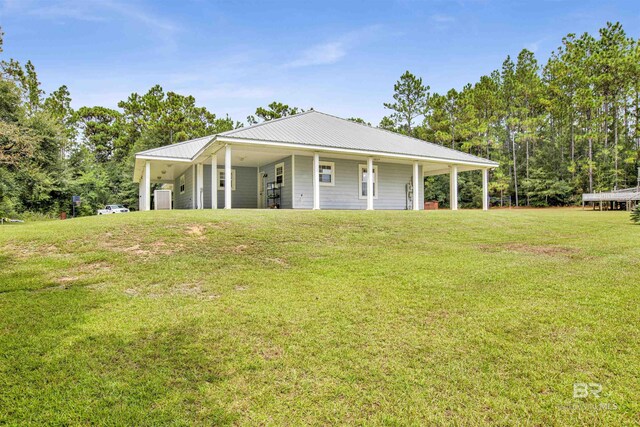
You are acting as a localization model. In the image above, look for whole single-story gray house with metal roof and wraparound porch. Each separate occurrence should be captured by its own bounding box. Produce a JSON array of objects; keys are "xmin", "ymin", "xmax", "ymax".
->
[{"xmin": 134, "ymin": 110, "xmax": 498, "ymax": 210}]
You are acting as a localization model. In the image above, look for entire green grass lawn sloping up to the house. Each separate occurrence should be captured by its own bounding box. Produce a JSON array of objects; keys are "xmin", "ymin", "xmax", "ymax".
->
[{"xmin": 0, "ymin": 209, "xmax": 640, "ymax": 425}]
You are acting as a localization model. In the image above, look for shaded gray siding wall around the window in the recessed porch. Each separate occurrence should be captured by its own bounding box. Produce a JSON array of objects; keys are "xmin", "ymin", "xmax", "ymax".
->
[{"xmin": 203, "ymin": 164, "xmax": 258, "ymax": 209}]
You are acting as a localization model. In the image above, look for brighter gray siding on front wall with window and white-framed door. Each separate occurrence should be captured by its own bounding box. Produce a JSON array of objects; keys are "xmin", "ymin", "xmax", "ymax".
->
[{"xmin": 294, "ymin": 156, "xmax": 424, "ymax": 209}]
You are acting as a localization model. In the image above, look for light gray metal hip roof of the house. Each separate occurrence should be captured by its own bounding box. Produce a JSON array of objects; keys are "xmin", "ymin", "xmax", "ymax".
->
[{"xmin": 137, "ymin": 110, "xmax": 498, "ymax": 166}]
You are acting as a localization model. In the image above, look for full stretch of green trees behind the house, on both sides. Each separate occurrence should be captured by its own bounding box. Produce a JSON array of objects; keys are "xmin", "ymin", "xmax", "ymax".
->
[{"xmin": 0, "ymin": 23, "xmax": 640, "ymax": 216}]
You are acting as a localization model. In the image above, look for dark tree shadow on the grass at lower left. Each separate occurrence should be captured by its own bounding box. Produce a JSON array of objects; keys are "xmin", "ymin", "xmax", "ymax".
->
[{"xmin": 0, "ymin": 286, "xmax": 238, "ymax": 425}]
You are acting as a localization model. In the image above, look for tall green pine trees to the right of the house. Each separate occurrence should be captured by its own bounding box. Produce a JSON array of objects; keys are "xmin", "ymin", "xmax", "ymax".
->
[{"xmin": 379, "ymin": 23, "xmax": 640, "ymax": 206}]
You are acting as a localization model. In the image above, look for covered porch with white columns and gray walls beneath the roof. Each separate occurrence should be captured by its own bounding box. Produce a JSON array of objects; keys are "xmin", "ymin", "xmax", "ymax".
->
[{"xmin": 134, "ymin": 137, "xmax": 489, "ymax": 210}]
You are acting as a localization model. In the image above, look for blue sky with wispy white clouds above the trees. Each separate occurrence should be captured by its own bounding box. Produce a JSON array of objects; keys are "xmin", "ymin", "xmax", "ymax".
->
[{"xmin": 0, "ymin": 0, "xmax": 640, "ymax": 124}]
